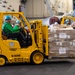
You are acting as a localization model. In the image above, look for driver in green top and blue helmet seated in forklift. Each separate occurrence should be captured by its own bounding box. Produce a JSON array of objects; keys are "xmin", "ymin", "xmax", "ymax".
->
[{"xmin": 2, "ymin": 15, "xmax": 25, "ymax": 47}]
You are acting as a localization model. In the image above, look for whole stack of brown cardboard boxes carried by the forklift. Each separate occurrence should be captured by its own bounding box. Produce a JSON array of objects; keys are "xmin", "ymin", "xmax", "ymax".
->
[{"xmin": 48, "ymin": 25, "xmax": 75, "ymax": 57}]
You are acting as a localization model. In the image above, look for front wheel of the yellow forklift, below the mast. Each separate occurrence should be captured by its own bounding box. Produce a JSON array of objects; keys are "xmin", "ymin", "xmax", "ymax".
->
[{"xmin": 30, "ymin": 51, "xmax": 44, "ymax": 65}]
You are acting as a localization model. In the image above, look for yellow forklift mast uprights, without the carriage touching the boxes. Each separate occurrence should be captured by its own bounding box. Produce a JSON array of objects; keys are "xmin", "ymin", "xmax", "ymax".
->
[{"xmin": 30, "ymin": 20, "xmax": 43, "ymax": 52}]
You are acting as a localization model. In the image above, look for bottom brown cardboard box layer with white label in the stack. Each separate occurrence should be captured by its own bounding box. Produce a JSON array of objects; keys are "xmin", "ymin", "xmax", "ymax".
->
[{"xmin": 49, "ymin": 47, "xmax": 75, "ymax": 57}]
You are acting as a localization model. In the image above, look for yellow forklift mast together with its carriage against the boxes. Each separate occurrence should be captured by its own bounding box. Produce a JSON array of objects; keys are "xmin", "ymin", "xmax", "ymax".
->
[{"xmin": 30, "ymin": 20, "xmax": 48, "ymax": 56}]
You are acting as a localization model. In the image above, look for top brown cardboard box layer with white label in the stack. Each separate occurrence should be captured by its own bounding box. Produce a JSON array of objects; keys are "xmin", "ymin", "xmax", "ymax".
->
[{"xmin": 48, "ymin": 30, "xmax": 75, "ymax": 42}]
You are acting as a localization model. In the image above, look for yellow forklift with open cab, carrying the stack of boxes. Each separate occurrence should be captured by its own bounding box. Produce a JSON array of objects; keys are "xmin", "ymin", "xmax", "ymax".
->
[{"xmin": 0, "ymin": 12, "xmax": 48, "ymax": 66}]
